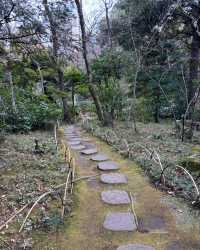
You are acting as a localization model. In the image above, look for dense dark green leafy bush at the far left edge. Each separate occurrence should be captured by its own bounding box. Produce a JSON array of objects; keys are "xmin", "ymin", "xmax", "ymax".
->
[{"xmin": 0, "ymin": 88, "xmax": 62, "ymax": 132}]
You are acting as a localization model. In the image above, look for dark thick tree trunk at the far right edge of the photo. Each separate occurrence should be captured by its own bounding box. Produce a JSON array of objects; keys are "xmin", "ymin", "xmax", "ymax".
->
[{"xmin": 188, "ymin": 35, "xmax": 200, "ymax": 119}]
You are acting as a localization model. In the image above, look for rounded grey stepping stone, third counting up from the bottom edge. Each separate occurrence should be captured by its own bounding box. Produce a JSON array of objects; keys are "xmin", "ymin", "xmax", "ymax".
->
[{"xmin": 101, "ymin": 190, "xmax": 131, "ymax": 205}]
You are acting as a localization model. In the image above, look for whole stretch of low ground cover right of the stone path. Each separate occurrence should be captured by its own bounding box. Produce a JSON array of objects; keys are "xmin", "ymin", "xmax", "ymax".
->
[{"xmin": 83, "ymin": 120, "xmax": 200, "ymax": 202}]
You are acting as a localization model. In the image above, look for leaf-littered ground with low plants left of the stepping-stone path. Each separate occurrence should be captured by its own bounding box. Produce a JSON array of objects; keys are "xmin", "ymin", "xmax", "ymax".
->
[{"xmin": 0, "ymin": 131, "xmax": 70, "ymax": 250}]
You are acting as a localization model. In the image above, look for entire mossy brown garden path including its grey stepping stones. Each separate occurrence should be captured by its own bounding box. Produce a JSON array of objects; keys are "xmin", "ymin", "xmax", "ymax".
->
[{"xmin": 61, "ymin": 126, "xmax": 200, "ymax": 250}]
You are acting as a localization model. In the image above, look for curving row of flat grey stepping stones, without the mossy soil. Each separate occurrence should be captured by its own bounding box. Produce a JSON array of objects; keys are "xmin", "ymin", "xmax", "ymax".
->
[{"xmin": 65, "ymin": 126, "xmax": 154, "ymax": 250}]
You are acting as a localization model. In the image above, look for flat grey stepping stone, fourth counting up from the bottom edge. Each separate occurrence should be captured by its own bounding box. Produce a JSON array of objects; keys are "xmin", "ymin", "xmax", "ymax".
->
[{"xmin": 100, "ymin": 173, "xmax": 128, "ymax": 184}]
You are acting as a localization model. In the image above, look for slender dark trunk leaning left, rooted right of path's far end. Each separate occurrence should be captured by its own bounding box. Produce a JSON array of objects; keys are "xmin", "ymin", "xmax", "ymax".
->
[{"xmin": 75, "ymin": 0, "xmax": 104, "ymax": 122}]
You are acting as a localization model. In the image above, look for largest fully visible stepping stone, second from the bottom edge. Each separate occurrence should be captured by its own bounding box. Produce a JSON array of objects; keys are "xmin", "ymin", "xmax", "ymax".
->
[{"xmin": 103, "ymin": 213, "xmax": 137, "ymax": 232}]
